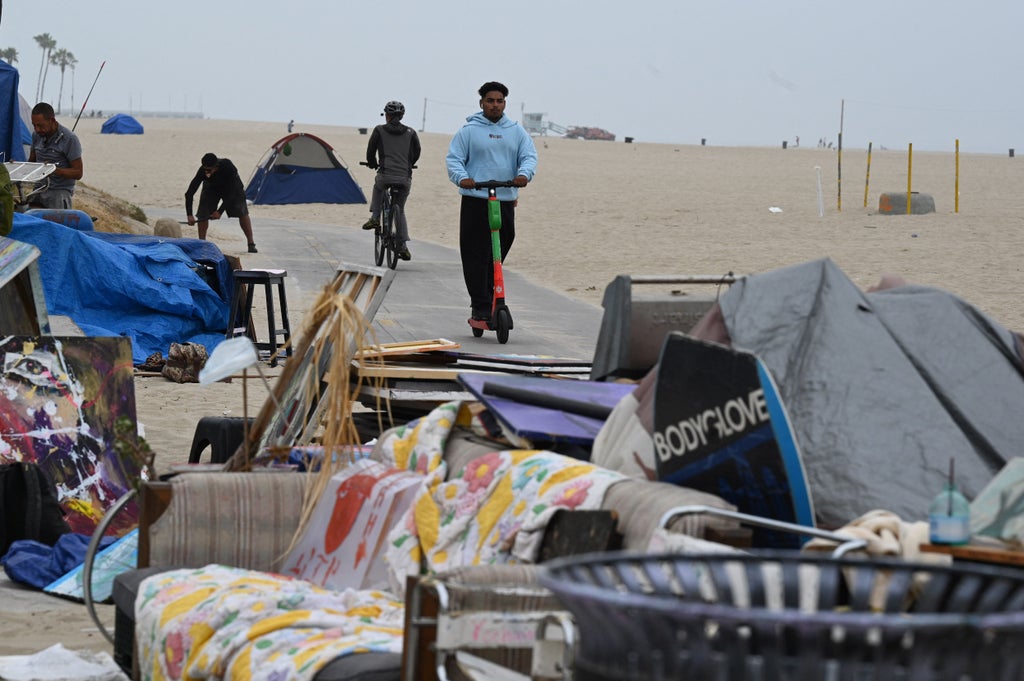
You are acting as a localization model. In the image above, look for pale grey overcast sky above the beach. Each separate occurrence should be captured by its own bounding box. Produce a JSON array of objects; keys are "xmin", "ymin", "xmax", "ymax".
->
[{"xmin": 0, "ymin": 0, "xmax": 1024, "ymax": 153}]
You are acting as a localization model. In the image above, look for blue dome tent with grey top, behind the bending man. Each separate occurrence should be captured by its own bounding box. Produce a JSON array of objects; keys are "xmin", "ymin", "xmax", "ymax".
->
[{"xmin": 246, "ymin": 132, "xmax": 367, "ymax": 205}]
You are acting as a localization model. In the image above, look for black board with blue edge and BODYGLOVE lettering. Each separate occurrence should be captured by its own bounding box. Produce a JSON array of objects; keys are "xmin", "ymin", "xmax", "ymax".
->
[{"xmin": 652, "ymin": 332, "xmax": 814, "ymax": 548}]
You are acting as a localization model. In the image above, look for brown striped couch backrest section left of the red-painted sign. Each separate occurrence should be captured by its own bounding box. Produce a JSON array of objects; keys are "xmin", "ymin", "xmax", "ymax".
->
[{"xmin": 150, "ymin": 472, "xmax": 308, "ymax": 571}]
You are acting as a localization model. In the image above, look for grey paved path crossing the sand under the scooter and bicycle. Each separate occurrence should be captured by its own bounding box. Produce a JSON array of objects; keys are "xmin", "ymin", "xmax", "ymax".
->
[{"xmin": 146, "ymin": 209, "xmax": 603, "ymax": 360}]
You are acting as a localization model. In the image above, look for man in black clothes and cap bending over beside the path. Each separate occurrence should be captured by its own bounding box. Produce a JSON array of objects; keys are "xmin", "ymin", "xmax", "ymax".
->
[{"xmin": 185, "ymin": 154, "xmax": 257, "ymax": 253}]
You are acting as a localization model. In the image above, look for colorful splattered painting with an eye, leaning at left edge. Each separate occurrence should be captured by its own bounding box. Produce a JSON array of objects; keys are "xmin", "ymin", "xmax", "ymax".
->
[{"xmin": 0, "ymin": 336, "xmax": 141, "ymax": 535}]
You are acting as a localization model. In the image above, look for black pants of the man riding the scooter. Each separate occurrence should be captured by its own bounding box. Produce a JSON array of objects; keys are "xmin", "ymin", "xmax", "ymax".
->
[{"xmin": 459, "ymin": 197, "xmax": 515, "ymax": 313}]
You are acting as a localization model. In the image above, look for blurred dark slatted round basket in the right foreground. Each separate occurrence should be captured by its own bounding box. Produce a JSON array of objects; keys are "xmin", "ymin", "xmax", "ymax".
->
[{"xmin": 540, "ymin": 552, "xmax": 1024, "ymax": 681}]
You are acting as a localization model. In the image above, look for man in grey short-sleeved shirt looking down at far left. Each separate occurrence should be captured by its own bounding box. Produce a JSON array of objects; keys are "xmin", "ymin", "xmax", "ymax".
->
[{"xmin": 29, "ymin": 101, "xmax": 82, "ymax": 210}]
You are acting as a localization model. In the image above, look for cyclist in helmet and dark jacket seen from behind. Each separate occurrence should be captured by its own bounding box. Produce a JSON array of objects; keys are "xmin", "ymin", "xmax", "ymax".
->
[{"xmin": 362, "ymin": 100, "xmax": 420, "ymax": 260}]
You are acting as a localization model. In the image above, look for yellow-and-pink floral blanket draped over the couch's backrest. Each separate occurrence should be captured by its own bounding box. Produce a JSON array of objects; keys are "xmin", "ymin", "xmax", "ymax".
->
[{"xmin": 380, "ymin": 402, "xmax": 626, "ymax": 593}]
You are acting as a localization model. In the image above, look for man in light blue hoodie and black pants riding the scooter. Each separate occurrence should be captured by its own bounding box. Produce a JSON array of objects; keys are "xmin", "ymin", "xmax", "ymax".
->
[{"xmin": 444, "ymin": 82, "xmax": 537, "ymax": 320}]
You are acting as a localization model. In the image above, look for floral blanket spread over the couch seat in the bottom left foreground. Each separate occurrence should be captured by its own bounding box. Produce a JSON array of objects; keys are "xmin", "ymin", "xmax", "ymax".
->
[{"xmin": 135, "ymin": 565, "xmax": 404, "ymax": 681}]
